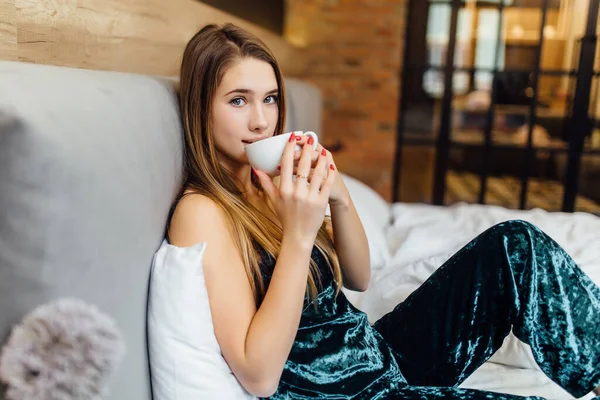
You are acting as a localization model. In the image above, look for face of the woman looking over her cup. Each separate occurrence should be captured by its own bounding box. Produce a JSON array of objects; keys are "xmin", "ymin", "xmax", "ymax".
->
[{"xmin": 212, "ymin": 58, "xmax": 279, "ymax": 168}]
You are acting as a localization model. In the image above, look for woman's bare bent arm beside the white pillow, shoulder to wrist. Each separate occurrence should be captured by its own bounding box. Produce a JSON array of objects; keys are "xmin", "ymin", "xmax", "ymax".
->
[{"xmin": 170, "ymin": 195, "xmax": 313, "ymax": 397}]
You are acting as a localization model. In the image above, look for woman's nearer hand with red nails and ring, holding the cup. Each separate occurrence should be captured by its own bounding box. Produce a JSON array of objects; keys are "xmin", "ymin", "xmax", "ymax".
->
[{"xmin": 254, "ymin": 134, "xmax": 338, "ymax": 246}]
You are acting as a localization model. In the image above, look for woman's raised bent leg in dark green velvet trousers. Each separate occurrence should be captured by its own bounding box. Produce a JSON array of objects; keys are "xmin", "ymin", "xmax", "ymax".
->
[{"xmin": 374, "ymin": 221, "xmax": 600, "ymax": 397}]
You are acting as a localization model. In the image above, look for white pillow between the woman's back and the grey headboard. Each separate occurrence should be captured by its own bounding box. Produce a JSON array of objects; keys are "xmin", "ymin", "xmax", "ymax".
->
[{"xmin": 148, "ymin": 240, "xmax": 255, "ymax": 400}]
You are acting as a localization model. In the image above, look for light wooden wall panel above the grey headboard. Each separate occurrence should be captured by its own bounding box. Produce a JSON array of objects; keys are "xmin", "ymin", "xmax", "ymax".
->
[{"xmin": 0, "ymin": 0, "xmax": 304, "ymax": 76}]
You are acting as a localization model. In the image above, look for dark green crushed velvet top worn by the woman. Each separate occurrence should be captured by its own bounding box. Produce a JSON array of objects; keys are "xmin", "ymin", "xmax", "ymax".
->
[{"xmin": 261, "ymin": 246, "xmax": 406, "ymax": 399}]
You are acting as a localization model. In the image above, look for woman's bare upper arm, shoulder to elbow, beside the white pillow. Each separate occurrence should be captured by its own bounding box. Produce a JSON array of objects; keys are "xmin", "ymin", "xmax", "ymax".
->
[{"xmin": 169, "ymin": 194, "xmax": 256, "ymax": 388}]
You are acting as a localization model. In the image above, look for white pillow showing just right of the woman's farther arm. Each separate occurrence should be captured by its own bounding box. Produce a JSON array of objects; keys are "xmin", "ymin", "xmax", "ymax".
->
[{"xmin": 342, "ymin": 174, "xmax": 391, "ymax": 270}]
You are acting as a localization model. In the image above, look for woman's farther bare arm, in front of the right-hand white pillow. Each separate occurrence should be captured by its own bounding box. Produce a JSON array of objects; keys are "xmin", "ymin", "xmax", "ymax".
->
[{"xmin": 329, "ymin": 184, "xmax": 371, "ymax": 292}]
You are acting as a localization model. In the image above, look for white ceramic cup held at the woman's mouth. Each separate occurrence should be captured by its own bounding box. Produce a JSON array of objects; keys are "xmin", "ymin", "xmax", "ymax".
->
[{"xmin": 244, "ymin": 131, "xmax": 319, "ymax": 176}]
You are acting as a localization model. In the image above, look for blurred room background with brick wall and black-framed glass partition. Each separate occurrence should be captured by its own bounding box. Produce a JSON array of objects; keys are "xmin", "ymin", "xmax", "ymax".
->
[{"xmin": 205, "ymin": 0, "xmax": 600, "ymax": 213}]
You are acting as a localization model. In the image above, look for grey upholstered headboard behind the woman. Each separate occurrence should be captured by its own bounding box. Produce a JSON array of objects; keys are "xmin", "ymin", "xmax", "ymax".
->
[{"xmin": 0, "ymin": 61, "xmax": 321, "ymax": 400}]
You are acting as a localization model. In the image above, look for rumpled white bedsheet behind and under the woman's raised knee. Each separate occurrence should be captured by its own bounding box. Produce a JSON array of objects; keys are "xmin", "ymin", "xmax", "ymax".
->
[{"xmin": 349, "ymin": 203, "xmax": 600, "ymax": 399}]
